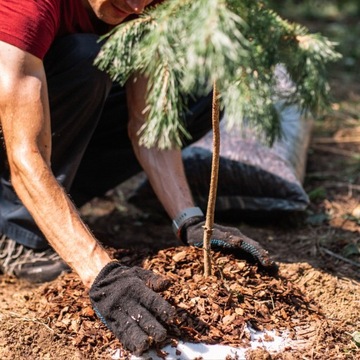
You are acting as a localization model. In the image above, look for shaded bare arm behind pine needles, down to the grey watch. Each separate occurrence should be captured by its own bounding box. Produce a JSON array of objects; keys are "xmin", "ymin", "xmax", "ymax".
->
[{"xmin": 126, "ymin": 76, "xmax": 194, "ymax": 219}]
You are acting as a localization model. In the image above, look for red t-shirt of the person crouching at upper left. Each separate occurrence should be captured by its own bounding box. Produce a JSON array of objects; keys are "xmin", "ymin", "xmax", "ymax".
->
[{"xmin": 0, "ymin": 0, "xmax": 96, "ymax": 59}]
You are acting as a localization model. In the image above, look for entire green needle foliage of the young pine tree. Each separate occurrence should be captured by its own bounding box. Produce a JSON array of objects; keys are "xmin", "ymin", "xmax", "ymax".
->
[{"xmin": 96, "ymin": 0, "xmax": 338, "ymax": 148}]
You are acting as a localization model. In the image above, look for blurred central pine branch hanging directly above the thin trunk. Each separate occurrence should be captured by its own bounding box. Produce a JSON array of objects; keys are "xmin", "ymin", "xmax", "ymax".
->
[{"xmin": 175, "ymin": 0, "xmax": 248, "ymax": 96}]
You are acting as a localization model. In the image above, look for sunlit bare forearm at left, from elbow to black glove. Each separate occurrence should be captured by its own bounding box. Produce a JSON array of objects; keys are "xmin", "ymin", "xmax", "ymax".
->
[{"xmin": 12, "ymin": 159, "xmax": 111, "ymax": 287}]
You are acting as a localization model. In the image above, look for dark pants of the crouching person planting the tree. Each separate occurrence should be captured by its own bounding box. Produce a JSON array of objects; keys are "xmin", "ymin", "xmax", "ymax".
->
[{"xmin": 0, "ymin": 34, "xmax": 211, "ymax": 249}]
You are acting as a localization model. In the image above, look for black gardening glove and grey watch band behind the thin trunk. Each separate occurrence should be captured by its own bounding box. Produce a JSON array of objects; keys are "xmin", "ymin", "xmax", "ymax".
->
[{"xmin": 173, "ymin": 208, "xmax": 277, "ymax": 270}]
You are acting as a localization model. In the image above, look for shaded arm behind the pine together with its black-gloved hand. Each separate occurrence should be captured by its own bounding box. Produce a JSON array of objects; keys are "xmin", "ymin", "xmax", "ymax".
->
[{"xmin": 127, "ymin": 77, "xmax": 276, "ymax": 269}]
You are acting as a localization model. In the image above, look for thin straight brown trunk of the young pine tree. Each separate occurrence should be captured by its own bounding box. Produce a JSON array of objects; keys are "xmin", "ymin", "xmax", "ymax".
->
[{"xmin": 203, "ymin": 82, "xmax": 220, "ymax": 277}]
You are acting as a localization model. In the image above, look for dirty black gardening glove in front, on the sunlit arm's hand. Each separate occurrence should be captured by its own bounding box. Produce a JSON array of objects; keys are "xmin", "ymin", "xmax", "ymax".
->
[{"xmin": 89, "ymin": 262, "xmax": 176, "ymax": 356}]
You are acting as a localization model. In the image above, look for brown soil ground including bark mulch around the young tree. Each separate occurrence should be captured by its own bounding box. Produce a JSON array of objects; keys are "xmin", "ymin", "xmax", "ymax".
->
[{"xmin": 0, "ymin": 23, "xmax": 360, "ymax": 360}]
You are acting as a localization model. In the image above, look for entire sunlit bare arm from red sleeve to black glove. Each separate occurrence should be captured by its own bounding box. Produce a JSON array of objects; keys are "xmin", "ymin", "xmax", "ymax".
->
[{"xmin": 0, "ymin": 42, "xmax": 111, "ymax": 287}]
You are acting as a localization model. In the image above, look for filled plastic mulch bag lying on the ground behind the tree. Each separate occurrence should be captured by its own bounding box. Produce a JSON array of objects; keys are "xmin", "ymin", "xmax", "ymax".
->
[{"xmin": 129, "ymin": 69, "xmax": 312, "ymax": 213}]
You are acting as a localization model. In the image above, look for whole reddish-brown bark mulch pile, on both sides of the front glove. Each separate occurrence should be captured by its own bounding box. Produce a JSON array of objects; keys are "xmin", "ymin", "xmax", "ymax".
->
[{"xmin": 37, "ymin": 247, "xmax": 332, "ymax": 358}]
